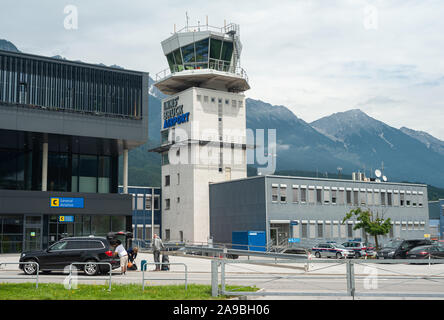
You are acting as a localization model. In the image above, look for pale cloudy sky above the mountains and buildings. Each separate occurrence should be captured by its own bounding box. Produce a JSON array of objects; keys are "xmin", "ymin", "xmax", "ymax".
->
[{"xmin": 0, "ymin": 0, "xmax": 444, "ymax": 140}]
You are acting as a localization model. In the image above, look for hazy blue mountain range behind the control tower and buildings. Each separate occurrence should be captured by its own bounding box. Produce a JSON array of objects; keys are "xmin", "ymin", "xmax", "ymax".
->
[{"xmin": 0, "ymin": 40, "xmax": 444, "ymax": 188}]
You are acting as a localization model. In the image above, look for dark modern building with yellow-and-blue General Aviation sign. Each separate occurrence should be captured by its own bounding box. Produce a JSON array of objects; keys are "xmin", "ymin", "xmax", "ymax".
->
[{"xmin": 0, "ymin": 51, "xmax": 148, "ymax": 253}]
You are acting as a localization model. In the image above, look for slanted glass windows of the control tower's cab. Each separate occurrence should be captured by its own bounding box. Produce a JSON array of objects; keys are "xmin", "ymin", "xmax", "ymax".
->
[{"xmin": 166, "ymin": 38, "xmax": 234, "ymax": 73}]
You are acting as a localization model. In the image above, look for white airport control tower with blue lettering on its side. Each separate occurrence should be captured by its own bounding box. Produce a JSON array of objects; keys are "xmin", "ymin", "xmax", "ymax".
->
[{"xmin": 150, "ymin": 24, "xmax": 250, "ymax": 242}]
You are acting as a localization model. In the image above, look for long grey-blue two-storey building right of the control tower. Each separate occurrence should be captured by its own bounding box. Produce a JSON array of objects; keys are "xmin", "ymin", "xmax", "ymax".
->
[{"xmin": 210, "ymin": 176, "xmax": 430, "ymax": 245}]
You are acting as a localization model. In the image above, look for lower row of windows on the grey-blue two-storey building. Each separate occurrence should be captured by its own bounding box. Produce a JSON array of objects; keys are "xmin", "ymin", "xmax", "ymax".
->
[{"xmin": 293, "ymin": 221, "xmax": 425, "ymax": 239}]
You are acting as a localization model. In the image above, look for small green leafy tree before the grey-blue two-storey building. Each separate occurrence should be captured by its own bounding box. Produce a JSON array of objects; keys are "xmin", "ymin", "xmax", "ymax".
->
[{"xmin": 342, "ymin": 208, "xmax": 392, "ymax": 250}]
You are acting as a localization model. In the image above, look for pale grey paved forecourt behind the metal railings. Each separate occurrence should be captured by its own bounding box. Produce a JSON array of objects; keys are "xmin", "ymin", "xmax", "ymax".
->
[{"xmin": 0, "ymin": 253, "xmax": 444, "ymax": 299}]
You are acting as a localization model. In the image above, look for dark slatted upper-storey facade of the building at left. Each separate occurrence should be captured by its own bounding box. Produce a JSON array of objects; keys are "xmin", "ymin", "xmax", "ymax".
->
[{"xmin": 0, "ymin": 52, "xmax": 142, "ymax": 119}]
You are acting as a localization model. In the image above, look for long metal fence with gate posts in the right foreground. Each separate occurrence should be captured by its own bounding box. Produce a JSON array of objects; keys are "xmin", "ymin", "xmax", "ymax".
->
[{"xmin": 211, "ymin": 259, "xmax": 444, "ymax": 299}]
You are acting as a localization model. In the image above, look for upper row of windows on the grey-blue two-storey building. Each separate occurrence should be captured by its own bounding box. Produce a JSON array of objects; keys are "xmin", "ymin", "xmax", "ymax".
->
[{"xmin": 271, "ymin": 184, "xmax": 424, "ymax": 207}]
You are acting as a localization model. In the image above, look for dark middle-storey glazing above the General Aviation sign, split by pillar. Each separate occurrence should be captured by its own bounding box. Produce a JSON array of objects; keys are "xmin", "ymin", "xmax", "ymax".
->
[{"xmin": 0, "ymin": 130, "xmax": 118, "ymax": 193}]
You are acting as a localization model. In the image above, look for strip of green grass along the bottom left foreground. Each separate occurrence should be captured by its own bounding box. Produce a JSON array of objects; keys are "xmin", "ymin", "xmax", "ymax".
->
[{"xmin": 0, "ymin": 283, "xmax": 258, "ymax": 300}]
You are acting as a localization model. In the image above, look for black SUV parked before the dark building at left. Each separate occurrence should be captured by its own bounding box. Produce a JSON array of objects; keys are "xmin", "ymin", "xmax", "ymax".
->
[{"xmin": 19, "ymin": 237, "xmax": 120, "ymax": 276}]
